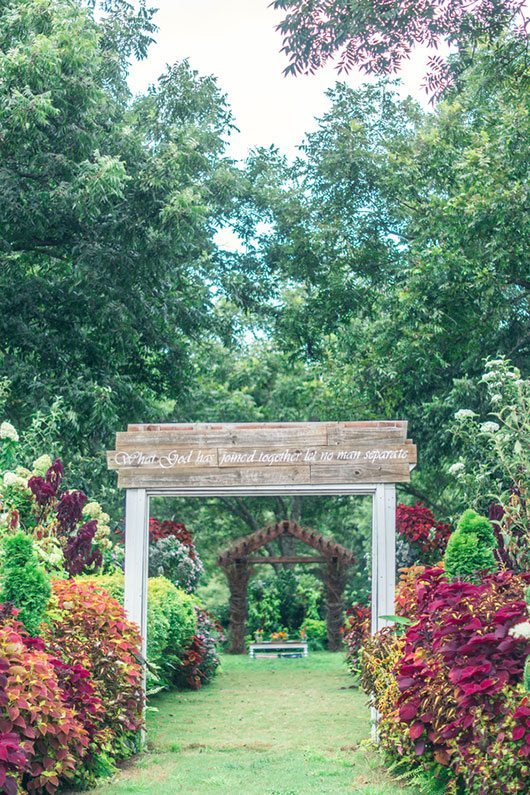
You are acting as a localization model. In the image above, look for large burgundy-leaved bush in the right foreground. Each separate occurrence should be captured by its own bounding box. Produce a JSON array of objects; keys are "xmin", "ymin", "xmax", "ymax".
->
[{"xmin": 396, "ymin": 569, "xmax": 530, "ymax": 780}]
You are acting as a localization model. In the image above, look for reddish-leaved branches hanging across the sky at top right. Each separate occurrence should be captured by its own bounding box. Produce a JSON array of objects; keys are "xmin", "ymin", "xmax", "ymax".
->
[{"xmin": 273, "ymin": 0, "xmax": 527, "ymax": 95}]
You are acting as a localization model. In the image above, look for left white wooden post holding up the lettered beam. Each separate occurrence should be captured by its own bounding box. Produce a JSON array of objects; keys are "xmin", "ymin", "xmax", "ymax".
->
[{"xmin": 124, "ymin": 489, "xmax": 149, "ymax": 659}]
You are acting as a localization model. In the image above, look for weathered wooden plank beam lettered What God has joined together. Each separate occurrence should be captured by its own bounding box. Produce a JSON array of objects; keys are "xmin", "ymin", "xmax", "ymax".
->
[{"xmin": 107, "ymin": 421, "xmax": 417, "ymax": 489}]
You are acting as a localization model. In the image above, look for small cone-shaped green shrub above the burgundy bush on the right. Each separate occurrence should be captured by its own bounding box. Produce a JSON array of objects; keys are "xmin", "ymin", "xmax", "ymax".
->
[{"xmin": 444, "ymin": 510, "xmax": 497, "ymax": 581}]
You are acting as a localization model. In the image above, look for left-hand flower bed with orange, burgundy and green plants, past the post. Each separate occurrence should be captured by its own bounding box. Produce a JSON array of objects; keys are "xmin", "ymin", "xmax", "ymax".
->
[{"xmin": 0, "ymin": 422, "xmax": 219, "ymax": 795}]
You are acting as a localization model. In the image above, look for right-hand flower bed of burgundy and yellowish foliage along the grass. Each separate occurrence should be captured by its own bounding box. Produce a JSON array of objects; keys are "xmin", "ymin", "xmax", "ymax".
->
[{"xmin": 361, "ymin": 556, "xmax": 530, "ymax": 795}]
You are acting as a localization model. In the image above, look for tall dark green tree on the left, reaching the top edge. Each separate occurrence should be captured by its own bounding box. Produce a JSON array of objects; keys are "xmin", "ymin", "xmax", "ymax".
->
[{"xmin": 0, "ymin": 0, "xmax": 257, "ymax": 498}]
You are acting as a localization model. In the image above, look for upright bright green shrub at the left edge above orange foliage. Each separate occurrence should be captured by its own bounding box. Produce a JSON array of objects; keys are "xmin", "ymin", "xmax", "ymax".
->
[{"xmin": 0, "ymin": 531, "xmax": 51, "ymax": 635}]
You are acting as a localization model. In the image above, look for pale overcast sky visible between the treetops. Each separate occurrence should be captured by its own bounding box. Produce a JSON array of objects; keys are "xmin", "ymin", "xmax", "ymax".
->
[{"xmin": 130, "ymin": 0, "xmax": 434, "ymax": 162}]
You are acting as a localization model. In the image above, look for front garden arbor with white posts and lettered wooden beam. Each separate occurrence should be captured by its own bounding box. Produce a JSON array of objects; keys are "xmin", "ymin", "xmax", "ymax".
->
[{"xmin": 107, "ymin": 421, "xmax": 416, "ymax": 652}]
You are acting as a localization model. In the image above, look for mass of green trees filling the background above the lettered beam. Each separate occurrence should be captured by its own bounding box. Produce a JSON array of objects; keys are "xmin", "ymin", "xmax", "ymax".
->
[{"xmin": 0, "ymin": 0, "xmax": 530, "ymax": 530}]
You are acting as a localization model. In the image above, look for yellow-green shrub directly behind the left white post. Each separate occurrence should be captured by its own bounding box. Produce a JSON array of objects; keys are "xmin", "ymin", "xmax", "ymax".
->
[{"xmin": 83, "ymin": 572, "xmax": 197, "ymax": 684}]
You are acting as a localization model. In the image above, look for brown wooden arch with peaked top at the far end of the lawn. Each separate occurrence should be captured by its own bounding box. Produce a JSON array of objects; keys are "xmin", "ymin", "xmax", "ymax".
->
[{"xmin": 217, "ymin": 520, "xmax": 355, "ymax": 654}]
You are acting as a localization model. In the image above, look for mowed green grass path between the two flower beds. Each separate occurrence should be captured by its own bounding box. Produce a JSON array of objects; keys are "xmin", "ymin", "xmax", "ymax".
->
[{"xmin": 82, "ymin": 652, "xmax": 414, "ymax": 795}]
